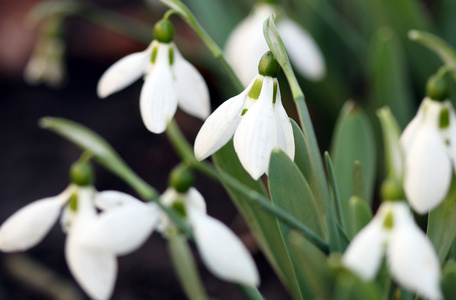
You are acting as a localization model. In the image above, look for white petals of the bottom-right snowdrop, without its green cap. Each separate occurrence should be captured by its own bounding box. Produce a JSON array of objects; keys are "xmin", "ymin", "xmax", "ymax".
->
[{"xmin": 342, "ymin": 201, "xmax": 442, "ymax": 299}]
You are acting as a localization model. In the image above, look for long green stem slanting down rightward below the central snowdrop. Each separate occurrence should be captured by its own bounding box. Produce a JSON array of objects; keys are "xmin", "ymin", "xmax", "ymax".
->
[{"xmin": 166, "ymin": 121, "xmax": 329, "ymax": 254}]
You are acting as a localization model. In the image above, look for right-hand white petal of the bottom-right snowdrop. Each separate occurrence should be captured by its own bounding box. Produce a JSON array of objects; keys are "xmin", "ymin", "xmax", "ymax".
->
[{"xmin": 387, "ymin": 204, "xmax": 442, "ymax": 299}]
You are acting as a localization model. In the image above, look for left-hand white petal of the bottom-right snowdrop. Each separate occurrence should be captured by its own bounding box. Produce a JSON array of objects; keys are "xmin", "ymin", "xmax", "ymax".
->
[{"xmin": 342, "ymin": 217, "xmax": 385, "ymax": 280}]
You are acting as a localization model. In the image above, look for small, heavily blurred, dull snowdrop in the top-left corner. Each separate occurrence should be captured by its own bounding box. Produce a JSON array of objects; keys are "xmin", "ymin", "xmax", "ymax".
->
[{"xmin": 24, "ymin": 19, "xmax": 66, "ymax": 87}]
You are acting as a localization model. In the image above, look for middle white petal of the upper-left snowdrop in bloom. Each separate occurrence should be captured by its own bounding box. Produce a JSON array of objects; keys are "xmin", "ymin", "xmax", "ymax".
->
[{"xmin": 140, "ymin": 44, "xmax": 177, "ymax": 133}]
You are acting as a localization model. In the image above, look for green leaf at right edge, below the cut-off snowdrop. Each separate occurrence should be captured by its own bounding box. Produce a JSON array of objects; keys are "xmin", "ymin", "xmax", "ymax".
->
[{"xmin": 427, "ymin": 176, "xmax": 456, "ymax": 262}]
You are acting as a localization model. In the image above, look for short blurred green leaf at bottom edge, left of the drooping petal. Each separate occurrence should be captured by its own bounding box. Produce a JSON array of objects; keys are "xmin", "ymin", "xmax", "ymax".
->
[{"xmin": 167, "ymin": 232, "xmax": 209, "ymax": 300}]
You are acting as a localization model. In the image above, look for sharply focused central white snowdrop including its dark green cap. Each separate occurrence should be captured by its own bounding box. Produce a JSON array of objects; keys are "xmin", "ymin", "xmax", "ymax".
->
[{"xmin": 195, "ymin": 52, "xmax": 295, "ymax": 180}]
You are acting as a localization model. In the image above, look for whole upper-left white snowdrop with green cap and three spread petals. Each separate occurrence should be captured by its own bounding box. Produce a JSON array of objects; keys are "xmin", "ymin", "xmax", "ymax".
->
[{"xmin": 97, "ymin": 20, "xmax": 210, "ymax": 133}]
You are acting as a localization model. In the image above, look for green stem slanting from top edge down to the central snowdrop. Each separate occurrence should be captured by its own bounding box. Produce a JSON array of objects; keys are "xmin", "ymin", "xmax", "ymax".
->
[{"xmin": 160, "ymin": 0, "xmax": 244, "ymax": 92}]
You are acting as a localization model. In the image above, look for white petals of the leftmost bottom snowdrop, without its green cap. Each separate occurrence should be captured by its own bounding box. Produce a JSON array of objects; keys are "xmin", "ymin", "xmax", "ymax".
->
[{"xmin": 0, "ymin": 185, "xmax": 158, "ymax": 299}]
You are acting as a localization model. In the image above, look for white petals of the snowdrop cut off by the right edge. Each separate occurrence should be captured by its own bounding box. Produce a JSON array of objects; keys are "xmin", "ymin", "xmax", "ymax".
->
[{"xmin": 400, "ymin": 98, "xmax": 456, "ymax": 214}]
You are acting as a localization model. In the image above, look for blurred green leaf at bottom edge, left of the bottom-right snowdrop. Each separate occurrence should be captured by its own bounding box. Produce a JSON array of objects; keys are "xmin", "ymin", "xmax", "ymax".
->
[{"xmin": 288, "ymin": 231, "xmax": 331, "ymax": 299}]
